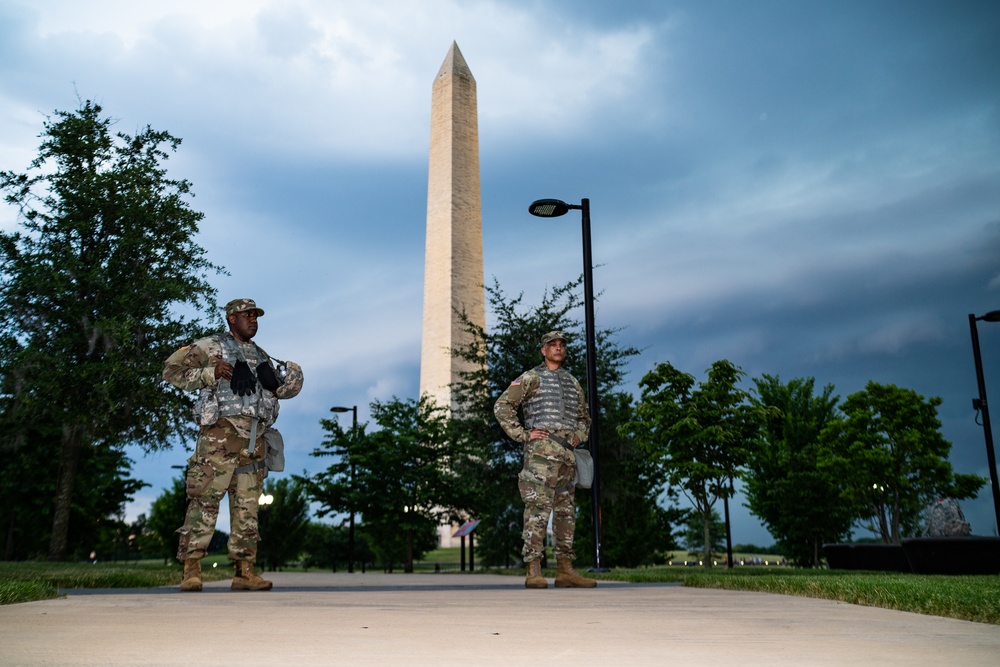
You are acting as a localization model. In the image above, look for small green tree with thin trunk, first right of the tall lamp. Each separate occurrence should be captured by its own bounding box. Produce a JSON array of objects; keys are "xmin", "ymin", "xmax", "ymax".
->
[{"xmin": 622, "ymin": 360, "xmax": 759, "ymax": 567}]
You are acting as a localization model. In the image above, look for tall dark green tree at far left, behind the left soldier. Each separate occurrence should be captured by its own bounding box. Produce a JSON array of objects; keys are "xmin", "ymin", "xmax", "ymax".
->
[{"xmin": 0, "ymin": 101, "xmax": 218, "ymax": 560}]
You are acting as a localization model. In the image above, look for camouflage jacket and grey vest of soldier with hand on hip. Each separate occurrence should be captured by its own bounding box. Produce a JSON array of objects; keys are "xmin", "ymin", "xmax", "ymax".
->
[{"xmin": 493, "ymin": 364, "xmax": 590, "ymax": 443}]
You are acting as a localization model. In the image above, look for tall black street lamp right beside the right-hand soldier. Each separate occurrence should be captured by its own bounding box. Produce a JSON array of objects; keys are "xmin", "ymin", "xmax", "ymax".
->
[{"xmin": 528, "ymin": 199, "xmax": 604, "ymax": 571}]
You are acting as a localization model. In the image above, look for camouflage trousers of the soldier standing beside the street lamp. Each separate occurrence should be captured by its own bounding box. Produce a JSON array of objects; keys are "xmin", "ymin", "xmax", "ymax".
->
[{"xmin": 517, "ymin": 438, "xmax": 576, "ymax": 563}]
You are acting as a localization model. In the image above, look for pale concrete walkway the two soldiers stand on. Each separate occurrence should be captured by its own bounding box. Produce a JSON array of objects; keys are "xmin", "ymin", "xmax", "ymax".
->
[{"xmin": 0, "ymin": 572, "xmax": 1000, "ymax": 667}]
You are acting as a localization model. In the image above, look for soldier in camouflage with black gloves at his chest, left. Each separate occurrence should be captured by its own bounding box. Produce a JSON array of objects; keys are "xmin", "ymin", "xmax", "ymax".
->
[{"xmin": 163, "ymin": 299, "xmax": 302, "ymax": 591}]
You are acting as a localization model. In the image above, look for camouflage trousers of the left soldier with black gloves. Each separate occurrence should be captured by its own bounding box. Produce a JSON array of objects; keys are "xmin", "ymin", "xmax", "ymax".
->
[{"xmin": 177, "ymin": 419, "xmax": 267, "ymax": 563}]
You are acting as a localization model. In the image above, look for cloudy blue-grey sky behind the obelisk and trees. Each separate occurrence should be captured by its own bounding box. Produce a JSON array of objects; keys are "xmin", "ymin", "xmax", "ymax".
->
[{"xmin": 0, "ymin": 0, "xmax": 1000, "ymax": 544}]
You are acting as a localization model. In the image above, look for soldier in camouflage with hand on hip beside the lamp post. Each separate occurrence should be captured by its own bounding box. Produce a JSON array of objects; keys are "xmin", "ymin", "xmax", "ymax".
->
[{"xmin": 493, "ymin": 331, "xmax": 597, "ymax": 588}]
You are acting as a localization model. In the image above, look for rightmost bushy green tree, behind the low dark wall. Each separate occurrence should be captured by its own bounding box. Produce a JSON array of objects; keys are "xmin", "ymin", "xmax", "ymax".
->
[{"xmin": 819, "ymin": 382, "xmax": 986, "ymax": 544}]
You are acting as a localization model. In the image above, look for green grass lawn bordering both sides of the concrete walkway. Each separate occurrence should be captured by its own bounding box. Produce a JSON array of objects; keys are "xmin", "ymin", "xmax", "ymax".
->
[{"xmin": 0, "ymin": 549, "xmax": 1000, "ymax": 625}]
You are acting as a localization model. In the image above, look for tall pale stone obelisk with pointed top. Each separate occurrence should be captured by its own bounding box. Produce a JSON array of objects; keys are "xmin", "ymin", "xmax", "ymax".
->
[{"xmin": 420, "ymin": 42, "xmax": 486, "ymax": 410}]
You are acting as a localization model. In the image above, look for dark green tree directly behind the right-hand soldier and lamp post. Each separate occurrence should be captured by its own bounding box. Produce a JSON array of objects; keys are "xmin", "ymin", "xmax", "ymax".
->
[{"xmin": 452, "ymin": 278, "xmax": 673, "ymax": 566}]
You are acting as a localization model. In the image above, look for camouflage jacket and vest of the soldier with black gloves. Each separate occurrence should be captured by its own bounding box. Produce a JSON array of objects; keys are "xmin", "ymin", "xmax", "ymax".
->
[{"xmin": 163, "ymin": 332, "xmax": 302, "ymax": 437}]
